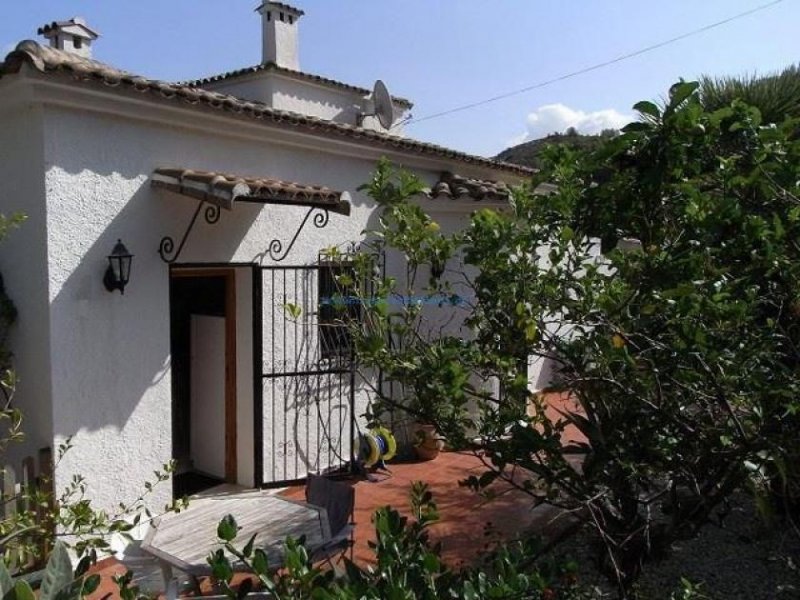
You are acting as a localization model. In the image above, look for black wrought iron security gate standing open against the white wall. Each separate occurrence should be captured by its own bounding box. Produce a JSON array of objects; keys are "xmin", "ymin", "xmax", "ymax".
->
[{"xmin": 253, "ymin": 253, "xmax": 382, "ymax": 485}]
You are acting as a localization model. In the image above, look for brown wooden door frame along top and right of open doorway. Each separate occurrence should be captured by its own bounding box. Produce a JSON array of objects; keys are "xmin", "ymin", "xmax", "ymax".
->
[{"xmin": 170, "ymin": 266, "xmax": 239, "ymax": 483}]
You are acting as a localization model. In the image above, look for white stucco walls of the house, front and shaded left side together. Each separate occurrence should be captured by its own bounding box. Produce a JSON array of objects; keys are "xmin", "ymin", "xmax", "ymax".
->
[{"xmin": 0, "ymin": 61, "xmax": 524, "ymax": 509}]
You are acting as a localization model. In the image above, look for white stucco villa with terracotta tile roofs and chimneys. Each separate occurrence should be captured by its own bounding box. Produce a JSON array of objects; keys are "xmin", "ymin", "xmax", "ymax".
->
[{"xmin": 0, "ymin": 2, "xmax": 530, "ymax": 507}]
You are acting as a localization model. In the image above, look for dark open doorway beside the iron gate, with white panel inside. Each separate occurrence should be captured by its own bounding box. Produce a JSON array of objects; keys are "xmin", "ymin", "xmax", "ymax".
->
[{"xmin": 170, "ymin": 268, "xmax": 237, "ymax": 498}]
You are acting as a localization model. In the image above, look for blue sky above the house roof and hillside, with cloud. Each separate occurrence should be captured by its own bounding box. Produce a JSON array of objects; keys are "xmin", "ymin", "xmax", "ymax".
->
[{"xmin": 0, "ymin": 0, "xmax": 800, "ymax": 155}]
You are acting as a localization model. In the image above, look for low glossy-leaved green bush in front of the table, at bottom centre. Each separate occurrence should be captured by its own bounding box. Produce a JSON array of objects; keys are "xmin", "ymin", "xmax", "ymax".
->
[{"xmin": 208, "ymin": 482, "xmax": 599, "ymax": 600}]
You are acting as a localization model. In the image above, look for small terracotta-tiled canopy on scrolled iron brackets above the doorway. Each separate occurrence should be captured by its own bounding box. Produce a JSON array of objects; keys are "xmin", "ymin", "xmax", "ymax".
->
[{"xmin": 151, "ymin": 167, "xmax": 350, "ymax": 216}]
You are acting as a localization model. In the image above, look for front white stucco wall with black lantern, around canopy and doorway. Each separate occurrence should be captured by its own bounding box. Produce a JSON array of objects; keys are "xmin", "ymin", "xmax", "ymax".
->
[{"xmin": 36, "ymin": 97, "xmax": 424, "ymax": 507}]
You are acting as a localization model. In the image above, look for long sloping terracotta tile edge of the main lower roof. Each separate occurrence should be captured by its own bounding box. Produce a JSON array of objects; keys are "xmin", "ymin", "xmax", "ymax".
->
[{"xmin": 0, "ymin": 40, "xmax": 534, "ymax": 177}]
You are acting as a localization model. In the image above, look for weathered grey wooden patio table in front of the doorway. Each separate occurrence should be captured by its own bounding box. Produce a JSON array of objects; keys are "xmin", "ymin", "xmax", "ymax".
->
[{"xmin": 142, "ymin": 491, "xmax": 331, "ymax": 598}]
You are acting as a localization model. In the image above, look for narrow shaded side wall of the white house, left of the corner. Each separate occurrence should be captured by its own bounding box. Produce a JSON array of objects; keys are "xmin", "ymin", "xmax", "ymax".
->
[{"xmin": 0, "ymin": 96, "xmax": 53, "ymax": 463}]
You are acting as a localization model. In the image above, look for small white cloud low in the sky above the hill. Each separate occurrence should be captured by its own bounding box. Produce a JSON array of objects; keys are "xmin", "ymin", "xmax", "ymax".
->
[{"xmin": 511, "ymin": 104, "xmax": 634, "ymax": 145}]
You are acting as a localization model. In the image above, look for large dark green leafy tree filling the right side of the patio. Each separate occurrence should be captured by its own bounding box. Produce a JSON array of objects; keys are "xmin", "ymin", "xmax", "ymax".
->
[{"xmin": 342, "ymin": 82, "xmax": 800, "ymax": 595}]
